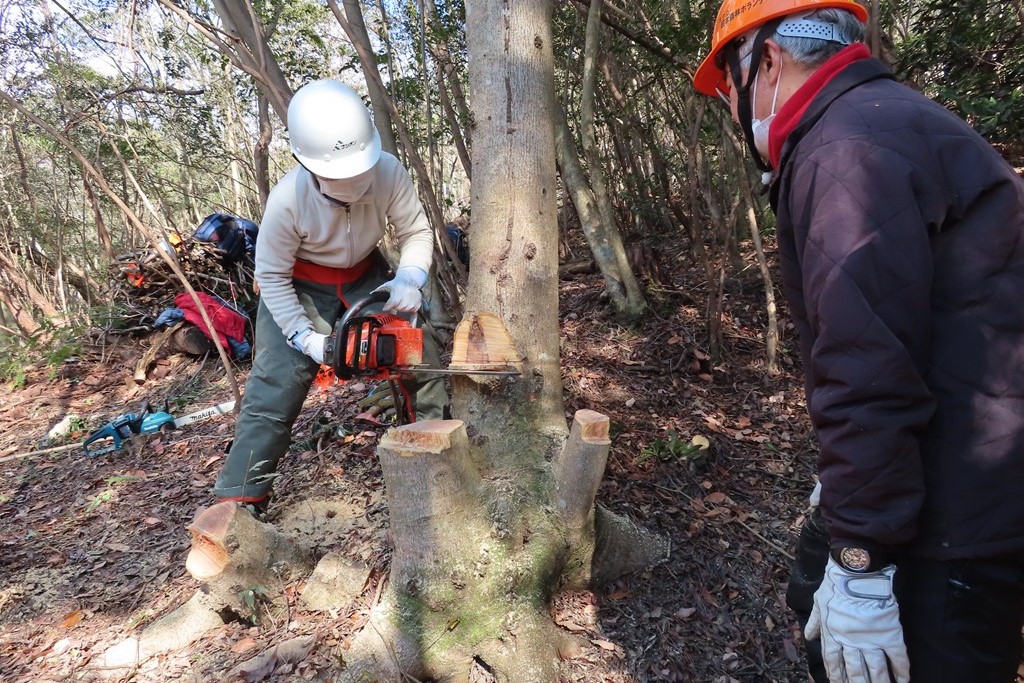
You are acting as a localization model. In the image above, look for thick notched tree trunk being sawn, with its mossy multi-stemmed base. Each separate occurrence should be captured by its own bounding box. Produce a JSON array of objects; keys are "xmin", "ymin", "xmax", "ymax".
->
[{"xmin": 331, "ymin": 0, "xmax": 667, "ymax": 683}]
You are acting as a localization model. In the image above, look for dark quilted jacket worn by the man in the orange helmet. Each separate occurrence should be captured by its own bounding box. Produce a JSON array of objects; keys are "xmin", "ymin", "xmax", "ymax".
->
[{"xmin": 772, "ymin": 59, "xmax": 1024, "ymax": 558}]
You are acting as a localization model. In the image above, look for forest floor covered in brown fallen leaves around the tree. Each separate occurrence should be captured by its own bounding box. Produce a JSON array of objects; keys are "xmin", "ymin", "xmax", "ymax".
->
[{"xmin": 0, "ymin": 232, "xmax": 815, "ymax": 683}]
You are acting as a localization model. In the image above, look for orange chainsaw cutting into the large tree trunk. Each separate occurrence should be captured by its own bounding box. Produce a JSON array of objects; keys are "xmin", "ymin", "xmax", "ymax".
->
[{"xmin": 324, "ymin": 290, "xmax": 519, "ymax": 421}]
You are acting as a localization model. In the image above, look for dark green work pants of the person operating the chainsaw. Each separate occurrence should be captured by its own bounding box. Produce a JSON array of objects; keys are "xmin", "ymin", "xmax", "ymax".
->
[{"xmin": 213, "ymin": 267, "xmax": 447, "ymax": 501}]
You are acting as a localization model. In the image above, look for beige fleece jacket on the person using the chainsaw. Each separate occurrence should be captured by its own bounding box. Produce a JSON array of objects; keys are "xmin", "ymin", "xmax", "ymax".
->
[{"xmin": 256, "ymin": 152, "xmax": 433, "ymax": 339}]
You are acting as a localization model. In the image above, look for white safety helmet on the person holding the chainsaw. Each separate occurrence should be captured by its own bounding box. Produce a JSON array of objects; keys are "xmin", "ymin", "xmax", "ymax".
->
[{"xmin": 288, "ymin": 80, "xmax": 381, "ymax": 179}]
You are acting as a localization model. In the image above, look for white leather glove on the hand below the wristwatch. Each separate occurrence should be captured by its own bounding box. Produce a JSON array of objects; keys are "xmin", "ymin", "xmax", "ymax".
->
[{"xmin": 804, "ymin": 557, "xmax": 910, "ymax": 683}]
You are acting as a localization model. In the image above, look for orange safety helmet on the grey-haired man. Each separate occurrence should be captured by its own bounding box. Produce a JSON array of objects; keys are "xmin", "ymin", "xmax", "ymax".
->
[{"xmin": 693, "ymin": 0, "xmax": 867, "ymax": 96}]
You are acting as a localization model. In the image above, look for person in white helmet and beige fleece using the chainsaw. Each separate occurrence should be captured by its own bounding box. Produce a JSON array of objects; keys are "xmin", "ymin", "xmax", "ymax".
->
[{"xmin": 214, "ymin": 80, "xmax": 447, "ymax": 509}]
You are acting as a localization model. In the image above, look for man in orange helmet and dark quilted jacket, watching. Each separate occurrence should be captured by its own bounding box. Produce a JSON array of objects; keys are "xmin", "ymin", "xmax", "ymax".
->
[{"xmin": 694, "ymin": 0, "xmax": 1024, "ymax": 683}]
